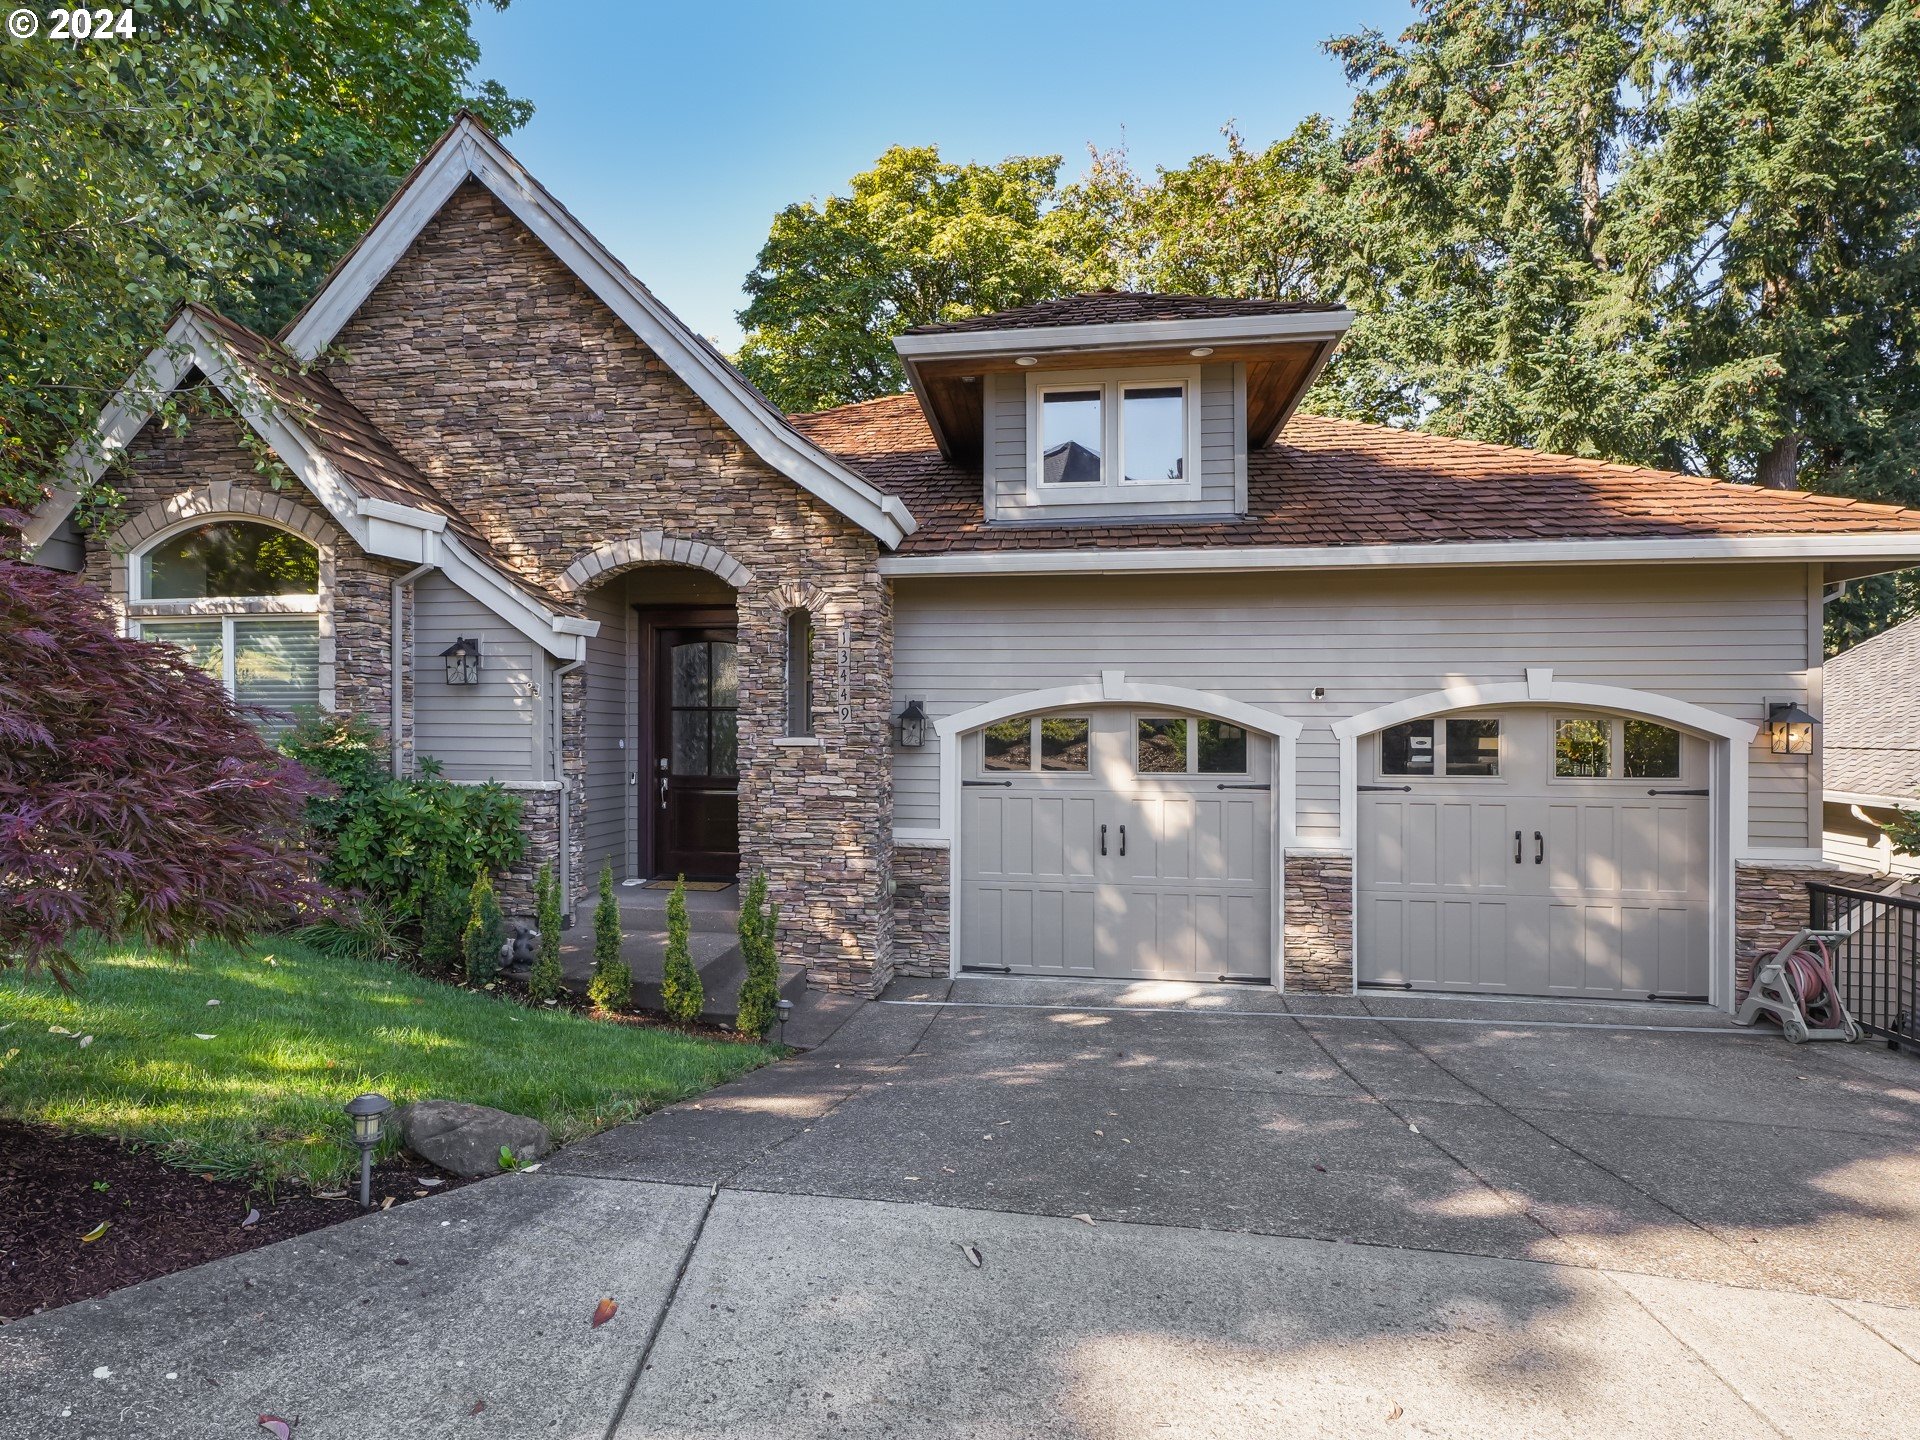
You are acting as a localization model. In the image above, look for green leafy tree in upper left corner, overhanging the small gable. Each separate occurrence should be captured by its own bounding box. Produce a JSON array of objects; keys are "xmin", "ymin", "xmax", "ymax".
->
[{"xmin": 0, "ymin": 0, "xmax": 530, "ymax": 516}]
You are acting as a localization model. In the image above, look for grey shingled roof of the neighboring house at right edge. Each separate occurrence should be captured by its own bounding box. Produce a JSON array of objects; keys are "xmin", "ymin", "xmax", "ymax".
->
[{"xmin": 1820, "ymin": 620, "xmax": 1920, "ymax": 799}]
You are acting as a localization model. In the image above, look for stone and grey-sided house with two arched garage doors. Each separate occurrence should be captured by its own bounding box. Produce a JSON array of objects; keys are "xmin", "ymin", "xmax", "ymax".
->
[{"xmin": 29, "ymin": 117, "xmax": 1920, "ymax": 1006}]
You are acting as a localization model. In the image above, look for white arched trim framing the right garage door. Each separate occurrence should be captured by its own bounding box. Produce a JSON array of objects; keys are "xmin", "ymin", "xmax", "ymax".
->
[{"xmin": 1332, "ymin": 666, "xmax": 1759, "ymax": 1010}]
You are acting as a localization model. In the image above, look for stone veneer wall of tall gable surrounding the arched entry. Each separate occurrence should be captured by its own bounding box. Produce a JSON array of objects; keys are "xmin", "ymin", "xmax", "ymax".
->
[{"xmin": 330, "ymin": 182, "xmax": 893, "ymax": 993}]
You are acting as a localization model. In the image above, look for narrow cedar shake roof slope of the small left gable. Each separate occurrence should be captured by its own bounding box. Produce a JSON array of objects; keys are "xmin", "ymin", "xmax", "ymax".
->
[{"xmin": 188, "ymin": 305, "xmax": 578, "ymax": 614}]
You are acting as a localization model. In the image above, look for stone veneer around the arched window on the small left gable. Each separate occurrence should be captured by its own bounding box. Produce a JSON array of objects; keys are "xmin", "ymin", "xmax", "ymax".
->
[{"xmin": 84, "ymin": 411, "xmax": 405, "ymax": 735}]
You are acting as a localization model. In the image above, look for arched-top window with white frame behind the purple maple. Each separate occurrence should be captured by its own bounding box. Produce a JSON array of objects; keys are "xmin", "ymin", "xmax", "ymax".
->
[{"xmin": 127, "ymin": 520, "xmax": 321, "ymax": 735}]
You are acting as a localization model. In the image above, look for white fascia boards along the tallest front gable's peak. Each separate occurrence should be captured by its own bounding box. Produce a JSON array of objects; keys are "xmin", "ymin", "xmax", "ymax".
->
[{"xmin": 284, "ymin": 119, "xmax": 916, "ymax": 549}]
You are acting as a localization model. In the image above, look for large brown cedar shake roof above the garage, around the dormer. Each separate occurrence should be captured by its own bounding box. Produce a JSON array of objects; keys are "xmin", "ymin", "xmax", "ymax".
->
[{"xmin": 793, "ymin": 396, "xmax": 1920, "ymax": 555}]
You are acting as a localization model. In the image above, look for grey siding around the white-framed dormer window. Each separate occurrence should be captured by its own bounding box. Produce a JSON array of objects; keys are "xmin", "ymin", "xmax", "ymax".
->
[{"xmin": 981, "ymin": 365, "xmax": 1246, "ymax": 520}]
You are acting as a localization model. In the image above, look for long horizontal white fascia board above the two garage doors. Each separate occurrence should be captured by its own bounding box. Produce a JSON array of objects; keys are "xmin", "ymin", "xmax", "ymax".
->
[{"xmin": 879, "ymin": 532, "xmax": 1920, "ymax": 578}]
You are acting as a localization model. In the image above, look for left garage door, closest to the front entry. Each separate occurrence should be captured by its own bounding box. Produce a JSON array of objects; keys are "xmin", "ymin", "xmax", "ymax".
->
[{"xmin": 960, "ymin": 710, "xmax": 1273, "ymax": 981}]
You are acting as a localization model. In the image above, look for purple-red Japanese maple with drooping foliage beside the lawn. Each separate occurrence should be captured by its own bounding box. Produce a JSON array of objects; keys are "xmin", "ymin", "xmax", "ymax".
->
[{"xmin": 0, "ymin": 549, "xmax": 324, "ymax": 977}]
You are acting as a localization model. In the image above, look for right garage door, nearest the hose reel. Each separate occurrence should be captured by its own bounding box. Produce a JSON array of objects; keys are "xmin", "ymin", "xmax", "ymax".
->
[{"xmin": 1356, "ymin": 710, "xmax": 1711, "ymax": 998}]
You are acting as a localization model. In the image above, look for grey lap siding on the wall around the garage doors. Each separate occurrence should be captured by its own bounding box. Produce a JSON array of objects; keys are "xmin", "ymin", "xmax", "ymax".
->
[{"xmin": 893, "ymin": 564, "xmax": 1818, "ymax": 849}]
